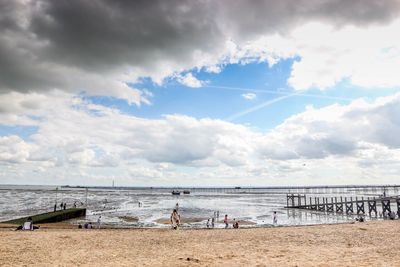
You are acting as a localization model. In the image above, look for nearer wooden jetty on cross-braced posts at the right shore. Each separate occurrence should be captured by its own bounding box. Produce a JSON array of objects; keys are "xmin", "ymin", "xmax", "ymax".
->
[{"xmin": 285, "ymin": 194, "xmax": 400, "ymax": 216}]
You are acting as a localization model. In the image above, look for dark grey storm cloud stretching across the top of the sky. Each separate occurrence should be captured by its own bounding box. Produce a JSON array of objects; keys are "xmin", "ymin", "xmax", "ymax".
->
[{"xmin": 0, "ymin": 0, "xmax": 399, "ymax": 98}]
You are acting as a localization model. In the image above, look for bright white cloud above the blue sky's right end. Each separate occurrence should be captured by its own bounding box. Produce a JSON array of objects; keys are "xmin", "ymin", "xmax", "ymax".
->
[{"xmin": 289, "ymin": 20, "xmax": 400, "ymax": 89}]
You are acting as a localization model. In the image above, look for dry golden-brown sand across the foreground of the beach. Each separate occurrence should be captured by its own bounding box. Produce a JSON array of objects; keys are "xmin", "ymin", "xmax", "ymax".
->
[{"xmin": 0, "ymin": 221, "xmax": 400, "ymax": 266}]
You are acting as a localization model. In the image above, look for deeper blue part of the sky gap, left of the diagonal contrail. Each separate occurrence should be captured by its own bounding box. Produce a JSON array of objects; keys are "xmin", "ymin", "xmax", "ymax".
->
[{"xmin": 86, "ymin": 61, "xmax": 291, "ymax": 122}]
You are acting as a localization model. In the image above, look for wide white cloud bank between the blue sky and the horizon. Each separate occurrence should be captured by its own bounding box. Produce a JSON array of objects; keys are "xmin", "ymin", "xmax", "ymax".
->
[{"xmin": 0, "ymin": 91, "xmax": 400, "ymax": 185}]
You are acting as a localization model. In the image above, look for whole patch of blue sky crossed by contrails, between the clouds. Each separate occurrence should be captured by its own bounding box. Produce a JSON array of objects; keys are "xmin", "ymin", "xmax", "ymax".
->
[{"xmin": 83, "ymin": 59, "xmax": 398, "ymax": 130}]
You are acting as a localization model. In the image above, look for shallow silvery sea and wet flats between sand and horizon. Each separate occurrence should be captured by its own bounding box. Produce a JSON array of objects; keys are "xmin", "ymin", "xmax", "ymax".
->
[{"xmin": 0, "ymin": 185, "xmax": 390, "ymax": 228}]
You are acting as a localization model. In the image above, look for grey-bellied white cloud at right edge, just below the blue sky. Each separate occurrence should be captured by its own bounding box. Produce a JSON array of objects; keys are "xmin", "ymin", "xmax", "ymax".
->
[{"xmin": 261, "ymin": 94, "xmax": 400, "ymax": 159}]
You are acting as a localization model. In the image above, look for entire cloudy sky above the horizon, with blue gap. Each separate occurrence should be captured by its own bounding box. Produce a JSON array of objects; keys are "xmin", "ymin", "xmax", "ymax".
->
[{"xmin": 0, "ymin": 0, "xmax": 400, "ymax": 187}]
